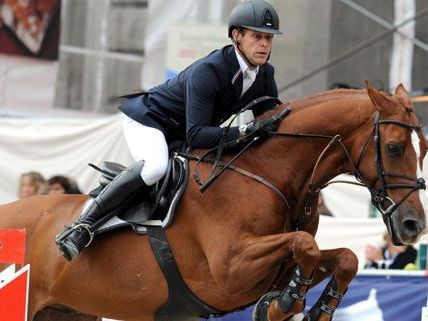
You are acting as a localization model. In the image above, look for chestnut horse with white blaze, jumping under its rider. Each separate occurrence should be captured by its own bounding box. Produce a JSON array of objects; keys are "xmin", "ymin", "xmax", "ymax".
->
[{"xmin": 0, "ymin": 83, "xmax": 427, "ymax": 321}]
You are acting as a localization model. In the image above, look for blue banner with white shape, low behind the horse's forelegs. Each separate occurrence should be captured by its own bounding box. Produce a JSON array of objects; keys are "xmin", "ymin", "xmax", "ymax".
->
[{"xmin": 210, "ymin": 271, "xmax": 428, "ymax": 321}]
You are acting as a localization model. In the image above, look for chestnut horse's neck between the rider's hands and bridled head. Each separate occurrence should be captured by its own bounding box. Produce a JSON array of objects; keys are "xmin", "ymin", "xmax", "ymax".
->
[{"xmin": 244, "ymin": 93, "xmax": 372, "ymax": 200}]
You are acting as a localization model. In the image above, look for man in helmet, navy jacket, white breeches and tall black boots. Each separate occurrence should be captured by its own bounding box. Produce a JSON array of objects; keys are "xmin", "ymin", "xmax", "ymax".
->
[{"xmin": 56, "ymin": 0, "xmax": 281, "ymax": 260}]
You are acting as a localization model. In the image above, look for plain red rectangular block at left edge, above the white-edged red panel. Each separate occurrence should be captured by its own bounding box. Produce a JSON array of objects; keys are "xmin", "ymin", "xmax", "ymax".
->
[{"xmin": 0, "ymin": 230, "xmax": 25, "ymax": 264}]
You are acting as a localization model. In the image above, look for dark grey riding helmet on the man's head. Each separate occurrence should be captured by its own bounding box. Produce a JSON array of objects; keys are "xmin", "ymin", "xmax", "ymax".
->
[{"xmin": 229, "ymin": 0, "xmax": 282, "ymax": 38}]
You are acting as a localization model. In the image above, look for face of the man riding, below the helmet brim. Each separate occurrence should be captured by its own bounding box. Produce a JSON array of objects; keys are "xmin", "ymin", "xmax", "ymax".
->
[{"xmin": 234, "ymin": 29, "xmax": 273, "ymax": 66}]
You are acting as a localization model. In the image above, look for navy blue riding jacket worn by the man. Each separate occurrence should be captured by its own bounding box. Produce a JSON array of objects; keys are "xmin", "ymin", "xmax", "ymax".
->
[{"xmin": 119, "ymin": 45, "xmax": 278, "ymax": 148}]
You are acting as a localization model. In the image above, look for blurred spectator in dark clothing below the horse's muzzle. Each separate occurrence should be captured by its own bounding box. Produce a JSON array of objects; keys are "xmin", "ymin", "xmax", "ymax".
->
[{"xmin": 365, "ymin": 232, "xmax": 417, "ymax": 270}]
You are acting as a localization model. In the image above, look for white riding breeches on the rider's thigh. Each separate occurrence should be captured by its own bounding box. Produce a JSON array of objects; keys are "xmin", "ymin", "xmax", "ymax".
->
[{"xmin": 123, "ymin": 115, "xmax": 168, "ymax": 185}]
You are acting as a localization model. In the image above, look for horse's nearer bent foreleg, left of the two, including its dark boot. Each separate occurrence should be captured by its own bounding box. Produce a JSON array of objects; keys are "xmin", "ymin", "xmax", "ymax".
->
[{"xmin": 232, "ymin": 231, "xmax": 321, "ymax": 321}]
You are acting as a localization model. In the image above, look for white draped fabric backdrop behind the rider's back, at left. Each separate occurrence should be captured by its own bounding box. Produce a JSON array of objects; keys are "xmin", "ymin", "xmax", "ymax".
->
[{"xmin": 0, "ymin": 114, "xmax": 131, "ymax": 203}]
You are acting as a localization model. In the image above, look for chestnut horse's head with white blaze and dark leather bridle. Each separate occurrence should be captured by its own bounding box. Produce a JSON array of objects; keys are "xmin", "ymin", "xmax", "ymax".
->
[{"xmin": 357, "ymin": 82, "xmax": 428, "ymax": 245}]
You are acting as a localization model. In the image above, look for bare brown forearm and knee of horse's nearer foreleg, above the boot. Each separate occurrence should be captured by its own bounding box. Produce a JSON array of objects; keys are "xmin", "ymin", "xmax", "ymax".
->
[{"xmin": 210, "ymin": 232, "xmax": 321, "ymax": 295}]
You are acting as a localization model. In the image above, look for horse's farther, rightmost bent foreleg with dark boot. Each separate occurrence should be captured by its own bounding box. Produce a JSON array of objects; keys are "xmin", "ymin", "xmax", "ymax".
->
[{"xmin": 303, "ymin": 248, "xmax": 358, "ymax": 321}]
